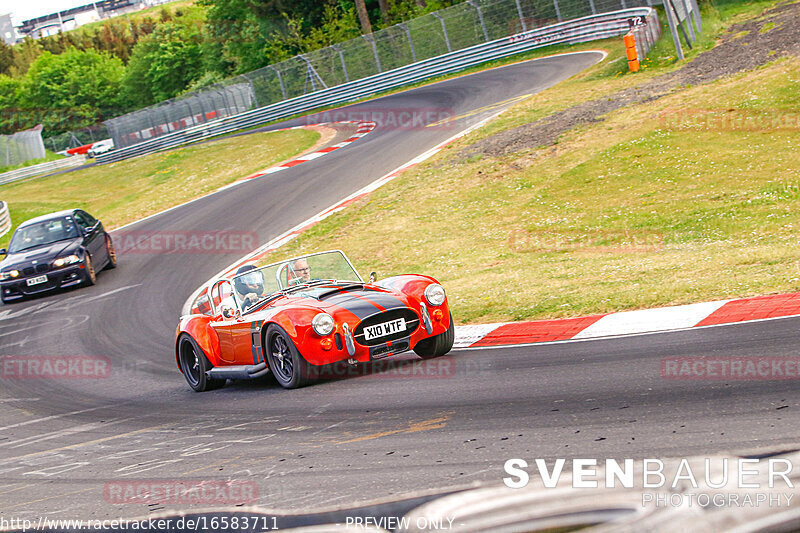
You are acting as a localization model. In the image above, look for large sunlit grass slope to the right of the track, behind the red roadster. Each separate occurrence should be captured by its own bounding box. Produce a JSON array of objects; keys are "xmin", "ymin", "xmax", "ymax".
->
[{"xmin": 268, "ymin": 3, "xmax": 800, "ymax": 323}]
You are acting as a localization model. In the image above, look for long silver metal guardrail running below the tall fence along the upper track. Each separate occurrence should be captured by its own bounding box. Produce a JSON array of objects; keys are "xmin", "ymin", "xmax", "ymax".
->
[{"xmin": 97, "ymin": 7, "xmax": 661, "ymax": 163}]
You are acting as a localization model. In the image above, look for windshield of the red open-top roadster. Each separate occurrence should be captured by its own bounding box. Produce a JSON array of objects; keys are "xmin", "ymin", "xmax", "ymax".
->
[{"xmin": 233, "ymin": 251, "xmax": 363, "ymax": 312}]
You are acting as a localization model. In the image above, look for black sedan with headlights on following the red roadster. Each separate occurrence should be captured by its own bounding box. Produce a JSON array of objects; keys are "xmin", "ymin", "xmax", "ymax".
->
[{"xmin": 0, "ymin": 209, "xmax": 117, "ymax": 303}]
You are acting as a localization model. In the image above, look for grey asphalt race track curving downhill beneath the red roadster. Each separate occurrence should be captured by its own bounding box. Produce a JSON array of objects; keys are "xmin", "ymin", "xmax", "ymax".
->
[{"xmin": 0, "ymin": 53, "xmax": 800, "ymax": 519}]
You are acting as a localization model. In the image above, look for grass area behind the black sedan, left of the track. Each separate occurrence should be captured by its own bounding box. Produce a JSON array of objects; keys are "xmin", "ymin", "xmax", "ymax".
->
[{"xmin": 0, "ymin": 130, "xmax": 320, "ymax": 248}]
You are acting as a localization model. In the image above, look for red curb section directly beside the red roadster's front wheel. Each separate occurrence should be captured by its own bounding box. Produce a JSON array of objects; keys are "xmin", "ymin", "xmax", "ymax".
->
[{"xmin": 469, "ymin": 315, "xmax": 606, "ymax": 348}]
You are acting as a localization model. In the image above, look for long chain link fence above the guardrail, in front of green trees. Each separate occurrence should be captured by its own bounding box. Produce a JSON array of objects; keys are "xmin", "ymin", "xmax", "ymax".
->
[{"xmin": 98, "ymin": 0, "xmax": 689, "ymax": 148}]
